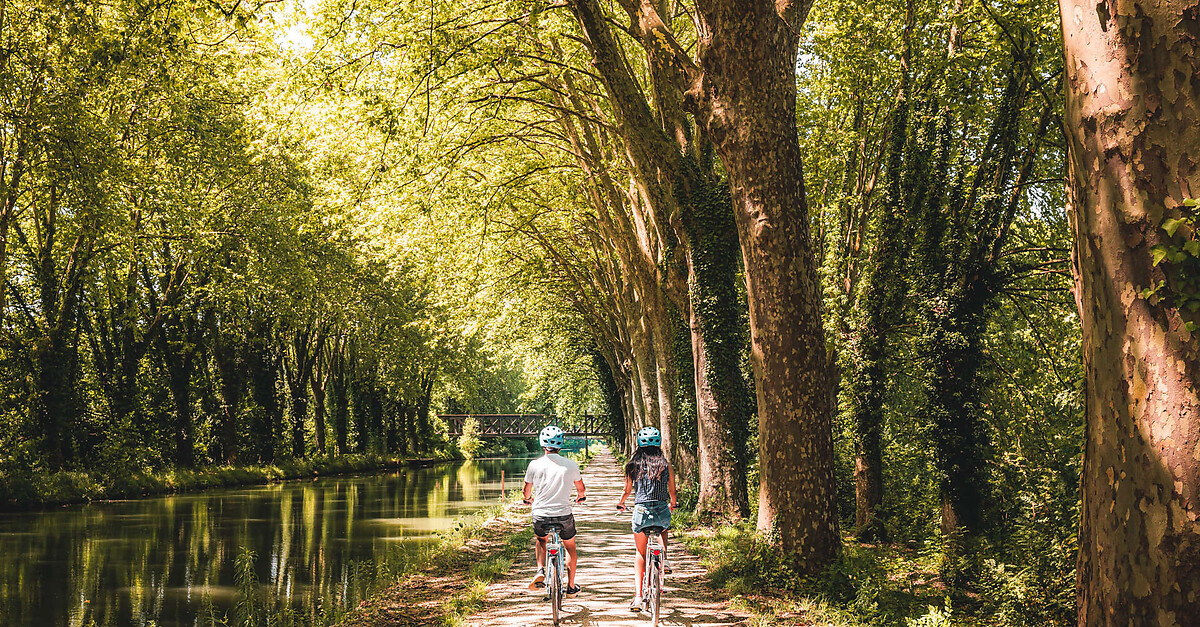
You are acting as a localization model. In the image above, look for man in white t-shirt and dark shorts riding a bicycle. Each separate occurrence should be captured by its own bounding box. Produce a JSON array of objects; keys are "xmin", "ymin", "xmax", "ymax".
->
[{"xmin": 524, "ymin": 425, "xmax": 587, "ymax": 597}]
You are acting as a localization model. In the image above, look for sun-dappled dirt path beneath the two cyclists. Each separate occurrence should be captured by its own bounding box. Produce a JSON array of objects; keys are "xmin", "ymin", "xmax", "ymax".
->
[{"xmin": 467, "ymin": 450, "xmax": 748, "ymax": 627}]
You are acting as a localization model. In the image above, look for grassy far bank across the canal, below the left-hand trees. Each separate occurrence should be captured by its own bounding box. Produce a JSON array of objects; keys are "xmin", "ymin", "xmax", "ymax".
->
[{"xmin": 0, "ymin": 455, "xmax": 455, "ymax": 512}]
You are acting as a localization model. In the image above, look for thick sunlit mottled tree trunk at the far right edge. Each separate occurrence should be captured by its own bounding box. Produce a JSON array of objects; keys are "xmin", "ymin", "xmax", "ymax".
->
[{"xmin": 1060, "ymin": 0, "xmax": 1200, "ymax": 627}]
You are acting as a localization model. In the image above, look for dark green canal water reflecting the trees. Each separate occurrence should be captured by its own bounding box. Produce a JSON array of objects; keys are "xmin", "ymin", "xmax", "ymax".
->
[{"xmin": 0, "ymin": 459, "xmax": 528, "ymax": 627}]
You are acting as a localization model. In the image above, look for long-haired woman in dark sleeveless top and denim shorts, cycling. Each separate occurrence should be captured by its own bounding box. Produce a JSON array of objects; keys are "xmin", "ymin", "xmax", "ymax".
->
[{"xmin": 617, "ymin": 426, "xmax": 676, "ymax": 611}]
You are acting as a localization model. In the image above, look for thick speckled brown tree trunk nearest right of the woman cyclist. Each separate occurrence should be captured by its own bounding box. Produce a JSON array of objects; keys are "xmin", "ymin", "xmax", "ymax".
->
[{"xmin": 697, "ymin": 0, "xmax": 841, "ymax": 573}]
